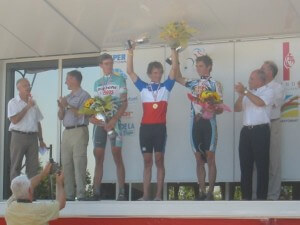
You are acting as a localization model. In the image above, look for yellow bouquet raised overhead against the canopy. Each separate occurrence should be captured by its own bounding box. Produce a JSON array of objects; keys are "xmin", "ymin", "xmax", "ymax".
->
[{"xmin": 160, "ymin": 21, "xmax": 196, "ymax": 48}]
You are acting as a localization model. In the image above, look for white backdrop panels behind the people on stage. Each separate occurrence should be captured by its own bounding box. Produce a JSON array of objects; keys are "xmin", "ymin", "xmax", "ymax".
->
[{"xmin": 103, "ymin": 38, "xmax": 300, "ymax": 182}]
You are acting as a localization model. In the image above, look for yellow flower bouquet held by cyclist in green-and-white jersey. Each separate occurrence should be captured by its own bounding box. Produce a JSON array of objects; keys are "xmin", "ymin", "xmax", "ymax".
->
[{"xmin": 79, "ymin": 96, "xmax": 118, "ymax": 138}]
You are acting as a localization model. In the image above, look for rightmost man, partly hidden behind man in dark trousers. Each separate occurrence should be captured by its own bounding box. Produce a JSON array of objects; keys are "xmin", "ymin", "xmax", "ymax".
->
[{"xmin": 261, "ymin": 61, "xmax": 284, "ymax": 200}]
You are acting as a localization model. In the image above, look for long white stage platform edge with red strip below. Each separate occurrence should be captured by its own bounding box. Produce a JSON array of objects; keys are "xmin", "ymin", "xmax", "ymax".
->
[{"xmin": 0, "ymin": 201, "xmax": 300, "ymax": 225}]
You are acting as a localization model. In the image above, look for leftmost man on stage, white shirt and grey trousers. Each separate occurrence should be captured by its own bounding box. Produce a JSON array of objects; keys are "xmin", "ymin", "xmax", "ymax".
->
[{"xmin": 7, "ymin": 78, "xmax": 46, "ymax": 180}]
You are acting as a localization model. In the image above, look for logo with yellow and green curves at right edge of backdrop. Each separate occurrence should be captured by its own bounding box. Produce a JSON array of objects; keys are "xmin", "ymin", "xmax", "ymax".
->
[{"xmin": 281, "ymin": 95, "xmax": 299, "ymax": 120}]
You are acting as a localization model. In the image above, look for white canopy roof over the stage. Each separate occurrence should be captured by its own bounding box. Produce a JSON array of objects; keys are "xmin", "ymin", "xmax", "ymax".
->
[{"xmin": 0, "ymin": 0, "xmax": 300, "ymax": 59}]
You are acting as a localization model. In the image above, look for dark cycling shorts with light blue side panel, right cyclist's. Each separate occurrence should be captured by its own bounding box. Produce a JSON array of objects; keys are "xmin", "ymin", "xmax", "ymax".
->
[{"xmin": 191, "ymin": 116, "xmax": 218, "ymax": 154}]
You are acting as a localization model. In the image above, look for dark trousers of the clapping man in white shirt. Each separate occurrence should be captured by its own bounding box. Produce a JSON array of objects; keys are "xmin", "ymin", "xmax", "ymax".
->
[{"xmin": 239, "ymin": 124, "xmax": 270, "ymax": 200}]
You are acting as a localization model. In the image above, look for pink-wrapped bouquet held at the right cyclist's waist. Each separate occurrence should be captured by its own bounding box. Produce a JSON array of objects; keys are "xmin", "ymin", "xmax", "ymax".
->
[{"xmin": 188, "ymin": 90, "xmax": 231, "ymax": 119}]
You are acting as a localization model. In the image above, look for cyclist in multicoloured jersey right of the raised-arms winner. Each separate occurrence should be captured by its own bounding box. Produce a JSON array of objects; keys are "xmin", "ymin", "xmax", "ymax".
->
[{"xmin": 176, "ymin": 55, "xmax": 223, "ymax": 200}]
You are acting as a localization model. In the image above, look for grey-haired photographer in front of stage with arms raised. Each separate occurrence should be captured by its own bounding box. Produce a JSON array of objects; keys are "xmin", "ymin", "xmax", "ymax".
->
[{"xmin": 5, "ymin": 163, "xmax": 66, "ymax": 225}]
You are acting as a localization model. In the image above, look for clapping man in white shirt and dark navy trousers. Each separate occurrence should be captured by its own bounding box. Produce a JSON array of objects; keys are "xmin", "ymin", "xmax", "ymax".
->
[{"xmin": 234, "ymin": 70, "xmax": 274, "ymax": 200}]
